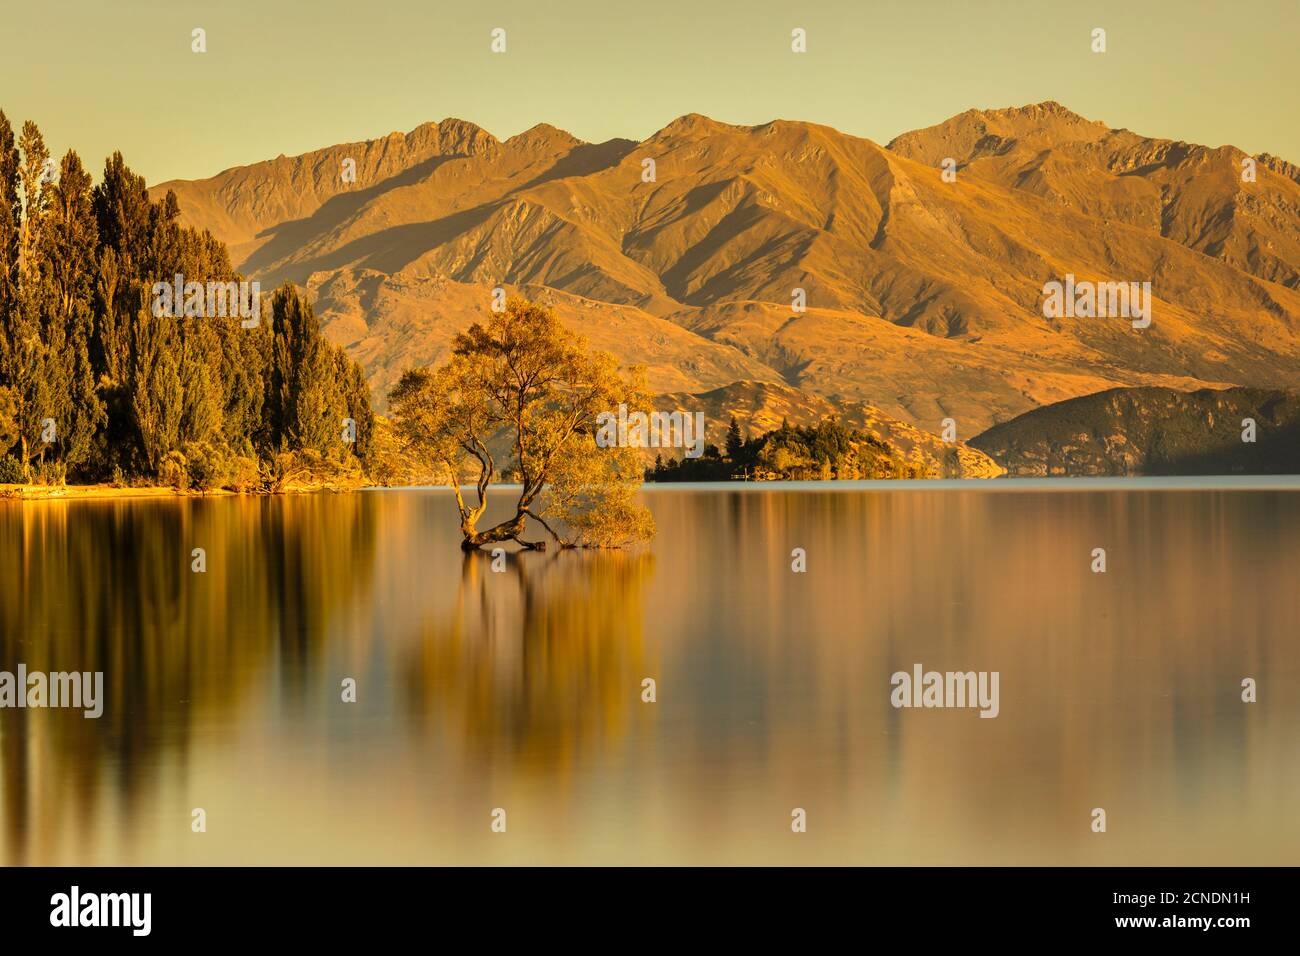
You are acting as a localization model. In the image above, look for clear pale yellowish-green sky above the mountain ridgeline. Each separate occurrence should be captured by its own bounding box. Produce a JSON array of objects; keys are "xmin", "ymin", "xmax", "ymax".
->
[{"xmin": 0, "ymin": 0, "xmax": 1300, "ymax": 183}]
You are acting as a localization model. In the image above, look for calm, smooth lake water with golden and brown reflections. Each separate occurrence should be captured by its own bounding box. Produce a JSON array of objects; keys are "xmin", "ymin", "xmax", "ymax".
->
[{"xmin": 0, "ymin": 483, "xmax": 1300, "ymax": 864}]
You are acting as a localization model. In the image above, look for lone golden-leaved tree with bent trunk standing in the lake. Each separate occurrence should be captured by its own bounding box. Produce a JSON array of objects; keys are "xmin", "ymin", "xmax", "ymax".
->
[{"xmin": 389, "ymin": 299, "xmax": 654, "ymax": 551}]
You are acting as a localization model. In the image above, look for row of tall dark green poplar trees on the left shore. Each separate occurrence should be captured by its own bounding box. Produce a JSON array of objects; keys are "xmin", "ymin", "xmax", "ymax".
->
[{"xmin": 0, "ymin": 112, "xmax": 373, "ymax": 485}]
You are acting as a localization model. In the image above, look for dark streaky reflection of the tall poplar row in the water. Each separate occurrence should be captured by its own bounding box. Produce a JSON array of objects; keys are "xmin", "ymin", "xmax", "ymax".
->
[{"xmin": 0, "ymin": 496, "xmax": 374, "ymax": 862}]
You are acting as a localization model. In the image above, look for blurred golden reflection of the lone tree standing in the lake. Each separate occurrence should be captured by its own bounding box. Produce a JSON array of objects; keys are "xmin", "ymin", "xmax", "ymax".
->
[{"xmin": 402, "ymin": 551, "xmax": 655, "ymax": 769}]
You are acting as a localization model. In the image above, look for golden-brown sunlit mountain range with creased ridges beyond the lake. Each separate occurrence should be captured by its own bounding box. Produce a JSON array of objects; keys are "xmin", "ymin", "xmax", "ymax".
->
[{"xmin": 151, "ymin": 103, "xmax": 1300, "ymax": 454}]
